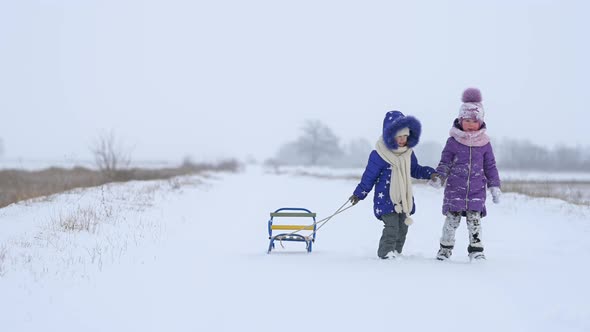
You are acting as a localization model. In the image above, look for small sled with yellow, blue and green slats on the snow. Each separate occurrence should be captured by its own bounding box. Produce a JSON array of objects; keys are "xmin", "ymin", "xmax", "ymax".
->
[{"xmin": 267, "ymin": 208, "xmax": 317, "ymax": 254}]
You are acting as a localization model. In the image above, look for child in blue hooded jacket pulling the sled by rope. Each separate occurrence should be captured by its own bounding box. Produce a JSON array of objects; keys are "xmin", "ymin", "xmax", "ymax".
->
[{"xmin": 350, "ymin": 111, "xmax": 436, "ymax": 259}]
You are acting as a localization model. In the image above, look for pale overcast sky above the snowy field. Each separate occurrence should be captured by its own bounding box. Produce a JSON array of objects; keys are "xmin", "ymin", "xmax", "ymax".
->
[{"xmin": 0, "ymin": 0, "xmax": 590, "ymax": 160}]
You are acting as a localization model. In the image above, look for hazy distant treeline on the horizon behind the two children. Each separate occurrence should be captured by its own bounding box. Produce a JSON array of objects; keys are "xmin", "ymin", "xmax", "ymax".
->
[{"xmin": 266, "ymin": 121, "xmax": 590, "ymax": 172}]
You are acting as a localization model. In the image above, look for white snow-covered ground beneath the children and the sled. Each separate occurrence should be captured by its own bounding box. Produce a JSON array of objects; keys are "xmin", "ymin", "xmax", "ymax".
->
[{"xmin": 0, "ymin": 166, "xmax": 590, "ymax": 332}]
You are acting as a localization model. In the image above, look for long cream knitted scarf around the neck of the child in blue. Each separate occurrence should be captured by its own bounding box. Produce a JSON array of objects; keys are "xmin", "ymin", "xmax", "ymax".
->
[{"xmin": 376, "ymin": 136, "xmax": 414, "ymax": 225}]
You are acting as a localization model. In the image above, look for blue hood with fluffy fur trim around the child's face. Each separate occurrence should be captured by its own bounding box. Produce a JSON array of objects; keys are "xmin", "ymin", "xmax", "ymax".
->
[{"xmin": 383, "ymin": 111, "xmax": 422, "ymax": 150}]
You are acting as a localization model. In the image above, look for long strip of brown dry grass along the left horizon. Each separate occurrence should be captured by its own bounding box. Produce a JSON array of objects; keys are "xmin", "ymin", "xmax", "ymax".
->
[{"xmin": 0, "ymin": 160, "xmax": 240, "ymax": 208}]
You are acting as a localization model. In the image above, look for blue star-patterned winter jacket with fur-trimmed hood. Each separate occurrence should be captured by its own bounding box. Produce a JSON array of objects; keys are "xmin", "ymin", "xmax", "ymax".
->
[{"xmin": 354, "ymin": 111, "xmax": 436, "ymax": 219}]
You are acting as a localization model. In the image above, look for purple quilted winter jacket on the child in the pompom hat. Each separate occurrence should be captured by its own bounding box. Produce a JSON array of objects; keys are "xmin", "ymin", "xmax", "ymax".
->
[{"xmin": 436, "ymin": 120, "xmax": 500, "ymax": 217}]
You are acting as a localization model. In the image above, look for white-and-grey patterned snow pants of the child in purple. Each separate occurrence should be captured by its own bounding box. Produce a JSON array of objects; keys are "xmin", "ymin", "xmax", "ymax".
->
[{"xmin": 440, "ymin": 211, "xmax": 483, "ymax": 253}]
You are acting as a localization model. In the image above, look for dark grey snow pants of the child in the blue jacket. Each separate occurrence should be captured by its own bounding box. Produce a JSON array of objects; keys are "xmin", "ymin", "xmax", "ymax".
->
[{"xmin": 377, "ymin": 213, "xmax": 408, "ymax": 257}]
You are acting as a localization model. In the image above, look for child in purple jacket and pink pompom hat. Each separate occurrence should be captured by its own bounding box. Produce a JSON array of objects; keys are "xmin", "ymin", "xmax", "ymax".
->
[{"xmin": 429, "ymin": 88, "xmax": 502, "ymax": 260}]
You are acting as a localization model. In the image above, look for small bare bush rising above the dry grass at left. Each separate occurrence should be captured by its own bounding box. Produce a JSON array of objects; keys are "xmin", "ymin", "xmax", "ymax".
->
[{"xmin": 91, "ymin": 131, "xmax": 131, "ymax": 179}]
